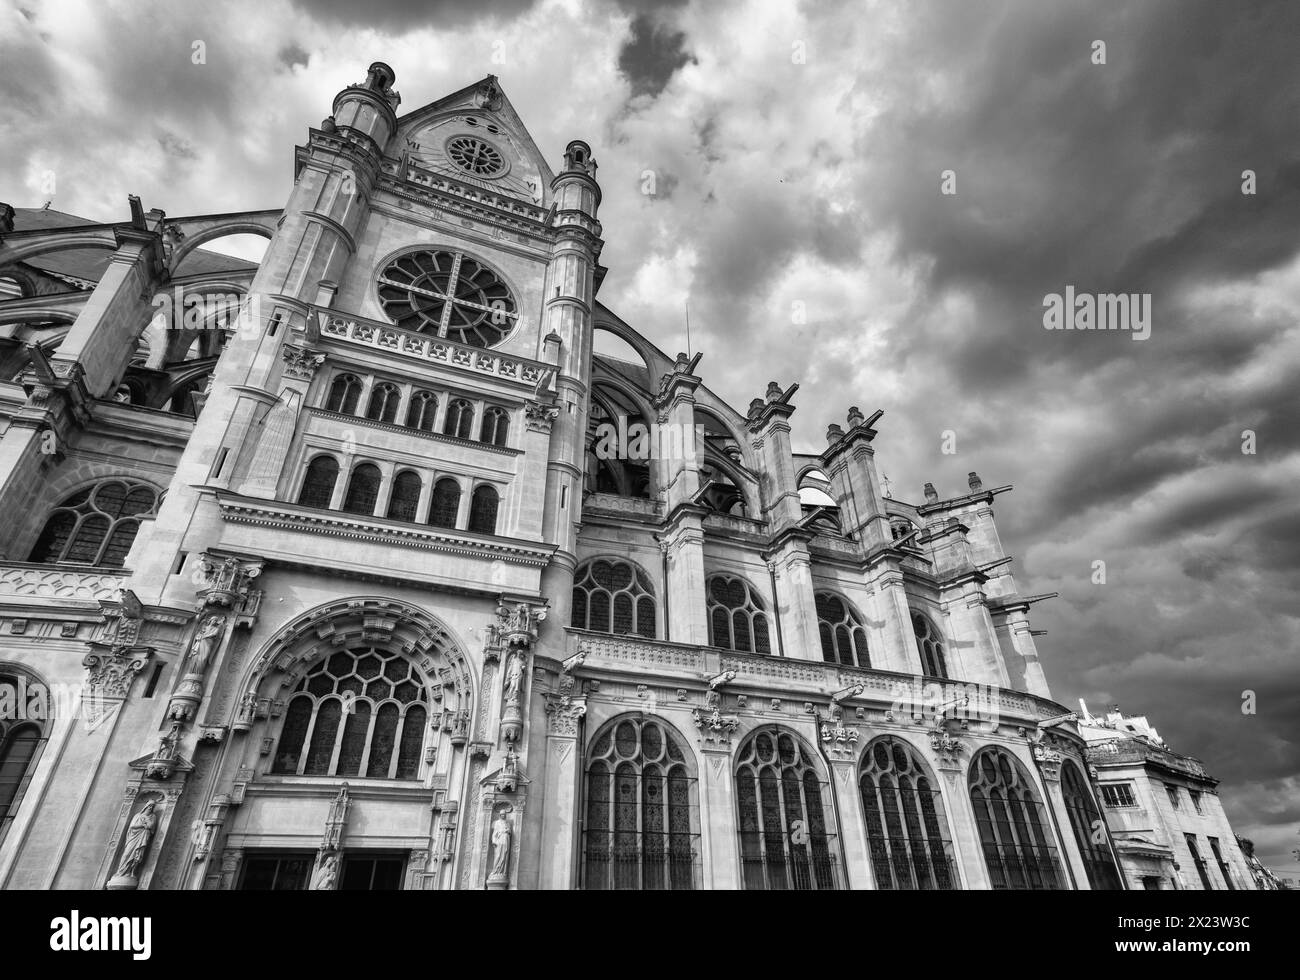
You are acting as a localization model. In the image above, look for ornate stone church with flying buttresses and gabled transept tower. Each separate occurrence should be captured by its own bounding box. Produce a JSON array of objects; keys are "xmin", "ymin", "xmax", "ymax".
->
[{"xmin": 0, "ymin": 64, "xmax": 1138, "ymax": 890}]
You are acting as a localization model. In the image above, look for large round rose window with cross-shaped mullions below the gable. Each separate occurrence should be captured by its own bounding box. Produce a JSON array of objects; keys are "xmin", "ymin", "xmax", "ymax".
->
[{"xmin": 378, "ymin": 251, "xmax": 519, "ymax": 347}]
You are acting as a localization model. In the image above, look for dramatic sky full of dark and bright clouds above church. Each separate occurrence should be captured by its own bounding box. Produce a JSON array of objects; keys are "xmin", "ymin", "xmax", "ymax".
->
[{"xmin": 0, "ymin": 0, "xmax": 1300, "ymax": 868}]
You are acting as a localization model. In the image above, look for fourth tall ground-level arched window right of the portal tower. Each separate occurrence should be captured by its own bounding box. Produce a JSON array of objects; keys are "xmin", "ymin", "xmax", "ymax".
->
[{"xmin": 970, "ymin": 749, "xmax": 1062, "ymax": 890}]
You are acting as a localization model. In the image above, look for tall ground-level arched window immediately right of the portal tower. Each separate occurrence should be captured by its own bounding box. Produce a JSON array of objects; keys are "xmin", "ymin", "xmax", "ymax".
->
[{"xmin": 582, "ymin": 719, "xmax": 699, "ymax": 890}]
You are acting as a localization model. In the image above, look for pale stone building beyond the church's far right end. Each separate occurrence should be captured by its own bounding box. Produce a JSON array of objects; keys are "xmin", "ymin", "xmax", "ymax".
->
[{"xmin": 1079, "ymin": 701, "xmax": 1260, "ymax": 892}]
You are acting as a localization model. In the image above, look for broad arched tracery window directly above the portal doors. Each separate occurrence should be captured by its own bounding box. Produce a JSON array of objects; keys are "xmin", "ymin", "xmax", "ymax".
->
[{"xmin": 273, "ymin": 646, "xmax": 429, "ymax": 780}]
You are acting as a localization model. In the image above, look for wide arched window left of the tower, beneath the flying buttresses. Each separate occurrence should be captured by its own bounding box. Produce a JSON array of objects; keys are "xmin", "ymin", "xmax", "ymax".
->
[{"xmin": 27, "ymin": 480, "xmax": 159, "ymax": 568}]
